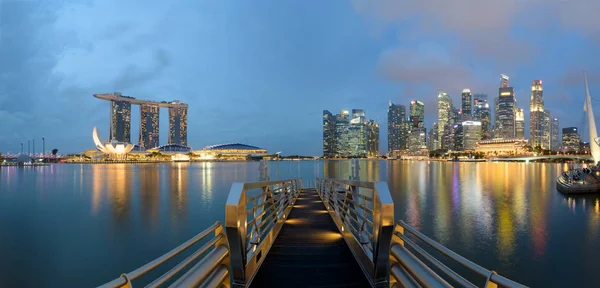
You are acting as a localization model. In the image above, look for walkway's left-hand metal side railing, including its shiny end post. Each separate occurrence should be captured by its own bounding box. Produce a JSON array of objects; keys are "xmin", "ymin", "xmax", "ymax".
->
[{"xmin": 225, "ymin": 179, "xmax": 301, "ymax": 287}]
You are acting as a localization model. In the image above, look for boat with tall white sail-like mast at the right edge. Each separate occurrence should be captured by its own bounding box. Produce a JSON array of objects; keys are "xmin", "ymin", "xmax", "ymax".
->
[{"xmin": 556, "ymin": 71, "xmax": 600, "ymax": 194}]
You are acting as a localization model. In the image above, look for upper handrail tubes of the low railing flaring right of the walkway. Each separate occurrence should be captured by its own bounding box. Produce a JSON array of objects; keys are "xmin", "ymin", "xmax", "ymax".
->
[{"xmin": 392, "ymin": 220, "xmax": 527, "ymax": 288}]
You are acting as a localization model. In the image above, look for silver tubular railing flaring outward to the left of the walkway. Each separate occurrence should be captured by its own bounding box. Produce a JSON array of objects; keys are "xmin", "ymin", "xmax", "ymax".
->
[{"xmin": 100, "ymin": 222, "xmax": 230, "ymax": 288}]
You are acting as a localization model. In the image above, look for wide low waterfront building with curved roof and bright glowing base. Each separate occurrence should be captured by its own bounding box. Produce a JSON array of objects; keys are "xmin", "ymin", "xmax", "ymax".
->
[{"xmin": 192, "ymin": 143, "xmax": 268, "ymax": 160}]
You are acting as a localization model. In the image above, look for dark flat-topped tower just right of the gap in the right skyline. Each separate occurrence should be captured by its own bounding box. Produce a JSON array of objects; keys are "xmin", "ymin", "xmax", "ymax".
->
[{"xmin": 388, "ymin": 102, "xmax": 408, "ymax": 156}]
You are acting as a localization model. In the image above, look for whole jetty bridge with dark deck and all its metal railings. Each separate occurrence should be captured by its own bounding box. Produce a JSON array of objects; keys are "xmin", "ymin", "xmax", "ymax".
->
[{"xmin": 100, "ymin": 179, "xmax": 525, "ymax": 288}]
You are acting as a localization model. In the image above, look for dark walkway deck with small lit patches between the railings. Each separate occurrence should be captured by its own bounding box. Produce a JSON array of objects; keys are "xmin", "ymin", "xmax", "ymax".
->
[{"xmin": 251, "ymin": 189, "xmax": 371, "ymax": 287}]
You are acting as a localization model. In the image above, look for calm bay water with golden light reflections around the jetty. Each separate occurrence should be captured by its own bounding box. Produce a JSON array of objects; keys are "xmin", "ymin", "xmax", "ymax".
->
[{"xmin": 0, "ymin": 161, "xmax": 600, "ymax": 287}]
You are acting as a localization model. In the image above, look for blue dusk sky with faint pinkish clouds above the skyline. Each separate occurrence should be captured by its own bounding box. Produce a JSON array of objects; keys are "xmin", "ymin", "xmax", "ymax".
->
[{"xmin": 0, "ymin": 0, "xmax": 600, "ymax": 155}]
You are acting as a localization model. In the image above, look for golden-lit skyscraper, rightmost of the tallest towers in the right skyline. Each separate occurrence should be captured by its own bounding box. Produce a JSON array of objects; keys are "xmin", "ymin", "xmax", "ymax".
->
[{"xmin": 529, "ymin": 80, "xmax": 546, "ymax": 148}]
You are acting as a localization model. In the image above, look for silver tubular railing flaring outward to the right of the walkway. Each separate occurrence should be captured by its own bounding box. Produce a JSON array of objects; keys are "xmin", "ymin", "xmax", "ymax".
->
[{"xmin": 390, "ymin": 221, "xmax": 526, "ymax": 288}]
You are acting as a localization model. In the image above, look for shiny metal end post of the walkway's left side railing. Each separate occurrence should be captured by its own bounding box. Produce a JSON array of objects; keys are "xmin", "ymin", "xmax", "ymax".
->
[{"xmin": 225, "ymin": 183, "xmax": 247, "ymax": 287}]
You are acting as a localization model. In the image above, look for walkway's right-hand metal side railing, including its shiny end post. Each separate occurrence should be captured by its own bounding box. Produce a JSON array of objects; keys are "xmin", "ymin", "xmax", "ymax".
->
[{"xmin": 316, "ymin": 179, "xmax": 394, "ymax": 287}]
